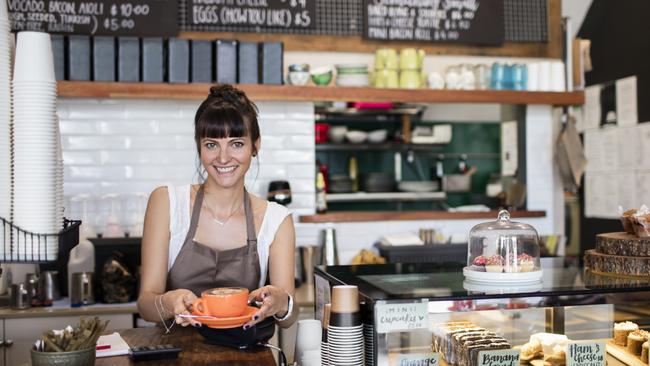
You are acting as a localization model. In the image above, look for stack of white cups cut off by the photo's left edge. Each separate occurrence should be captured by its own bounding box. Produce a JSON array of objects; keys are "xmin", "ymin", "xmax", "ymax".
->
[{"xmin": 0, "ymin": 1, "xmax": 12, "ymax": 258}]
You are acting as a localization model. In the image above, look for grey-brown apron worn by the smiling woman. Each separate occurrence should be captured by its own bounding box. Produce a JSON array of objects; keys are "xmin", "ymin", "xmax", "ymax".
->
[{"xmin": 167, "ymin": 185, "xmax": 260, "ymax": 297}]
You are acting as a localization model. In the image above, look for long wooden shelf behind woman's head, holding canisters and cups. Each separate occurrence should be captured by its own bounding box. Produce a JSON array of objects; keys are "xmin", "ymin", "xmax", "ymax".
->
[{"xmin": 58, "ymin": 81, "xmax": 585, "ymax": 105}]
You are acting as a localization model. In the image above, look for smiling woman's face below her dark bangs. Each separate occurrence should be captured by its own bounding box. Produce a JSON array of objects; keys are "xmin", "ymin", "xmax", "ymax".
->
[{"xmin": 200, "ymin": 136, "xmax": 259, "ymax": 188}]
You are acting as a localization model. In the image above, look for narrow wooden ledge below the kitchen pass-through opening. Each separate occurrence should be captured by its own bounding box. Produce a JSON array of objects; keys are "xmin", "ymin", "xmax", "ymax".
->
[{"xmin": 300, "ymin": 211, "xmax": 546, "ymax": 223}]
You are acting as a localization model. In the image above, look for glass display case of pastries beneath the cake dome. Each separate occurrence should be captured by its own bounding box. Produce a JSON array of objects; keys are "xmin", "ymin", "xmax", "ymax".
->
[{"xmin": 315, "ymin": 258, "xmax": 650, "ymax": 366}]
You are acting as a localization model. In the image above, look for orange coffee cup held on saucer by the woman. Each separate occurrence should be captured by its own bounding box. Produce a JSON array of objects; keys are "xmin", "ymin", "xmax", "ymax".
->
[{"xmin": 192, "ymin": 287, "xmax": 248, "ymax": 318}]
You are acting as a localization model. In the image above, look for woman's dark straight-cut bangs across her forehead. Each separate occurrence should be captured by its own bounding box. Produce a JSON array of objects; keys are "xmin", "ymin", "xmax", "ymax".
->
[{"xmin": 196, "ymin": 108, "xmax": 248, "ymax": 139}]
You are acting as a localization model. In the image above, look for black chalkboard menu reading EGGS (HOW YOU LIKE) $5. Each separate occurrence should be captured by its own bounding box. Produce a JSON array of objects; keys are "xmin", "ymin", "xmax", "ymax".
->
[{"xmin": 186, "ymin": 0, "xmax": 316, "ymax": 29}]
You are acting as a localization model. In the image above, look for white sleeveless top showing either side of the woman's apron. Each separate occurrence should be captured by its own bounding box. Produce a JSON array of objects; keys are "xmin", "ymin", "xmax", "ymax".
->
[{"xmin": 167, "ymin": 184, "xmax": 291, "ymax": 287}]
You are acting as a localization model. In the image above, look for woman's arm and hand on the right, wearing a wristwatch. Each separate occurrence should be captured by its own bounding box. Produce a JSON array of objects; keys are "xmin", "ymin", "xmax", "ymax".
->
[{"xmin": 245, "ymin": 215, "xmax": 299, "ymax": 328}]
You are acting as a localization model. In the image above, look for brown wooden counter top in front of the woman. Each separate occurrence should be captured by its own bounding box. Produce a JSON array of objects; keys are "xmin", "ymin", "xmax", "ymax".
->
[{"xmin": 95, "ymin": 327, "xmax": 276, "ymax": 366}]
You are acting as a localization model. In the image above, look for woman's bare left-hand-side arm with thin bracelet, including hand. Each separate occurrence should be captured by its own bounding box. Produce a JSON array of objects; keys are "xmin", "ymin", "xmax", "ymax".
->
[{"xmin": 138, "ymin": 187, "xmax": 196, "ymax": 326}]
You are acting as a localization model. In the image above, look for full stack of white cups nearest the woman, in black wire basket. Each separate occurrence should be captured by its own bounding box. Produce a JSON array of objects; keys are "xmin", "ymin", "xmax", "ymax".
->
[{"xmin": 12, "ymin": 32, "xmax": 63, "ymax": 260}]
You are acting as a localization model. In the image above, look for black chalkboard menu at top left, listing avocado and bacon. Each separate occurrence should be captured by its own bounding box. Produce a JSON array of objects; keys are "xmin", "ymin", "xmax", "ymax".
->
[{"xmin": 8, "ymin": 0, "xmax": 178, "ymax": 36}]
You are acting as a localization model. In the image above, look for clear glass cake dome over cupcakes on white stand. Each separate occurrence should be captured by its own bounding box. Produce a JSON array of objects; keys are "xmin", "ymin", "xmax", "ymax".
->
[{"xmin": 463, "ymin": 210, "xmax": 542, "ymax": 284}]
